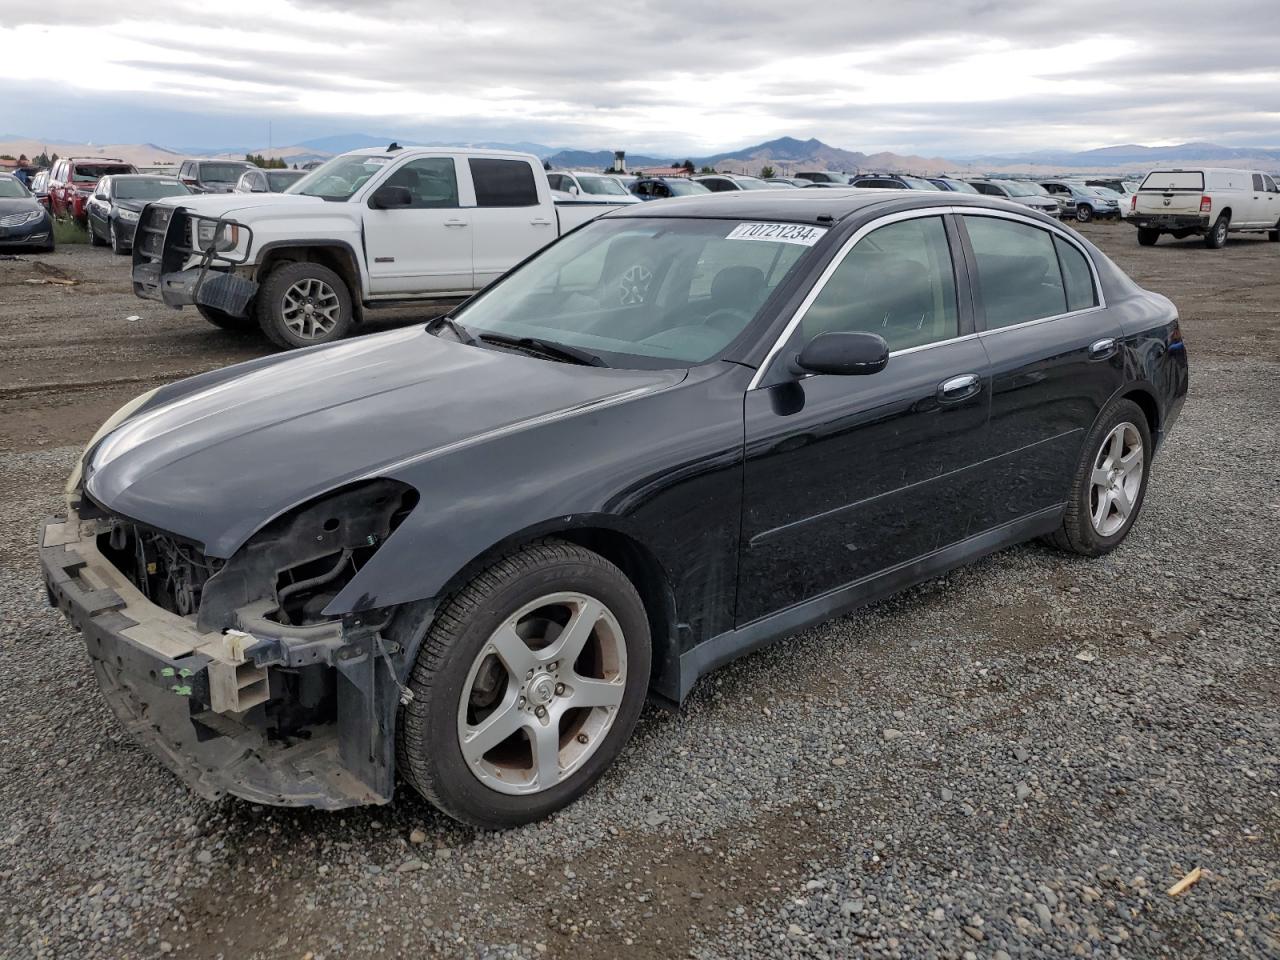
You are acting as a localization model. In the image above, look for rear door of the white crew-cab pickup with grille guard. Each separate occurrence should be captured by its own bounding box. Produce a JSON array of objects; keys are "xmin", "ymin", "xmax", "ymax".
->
[{"xmin": 467, "ymin": 156, "xmax": 558, "ymax": 289}]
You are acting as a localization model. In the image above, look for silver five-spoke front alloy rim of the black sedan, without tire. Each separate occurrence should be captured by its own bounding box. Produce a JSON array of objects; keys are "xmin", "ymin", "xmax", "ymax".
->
[{"xmin": 458, "ymin": 593, "xmax": 627, "ymax": 794}]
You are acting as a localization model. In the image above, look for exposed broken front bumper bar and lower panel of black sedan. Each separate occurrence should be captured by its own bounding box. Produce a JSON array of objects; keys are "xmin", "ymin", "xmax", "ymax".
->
[{"xmin": 40, "ymin": 508, "xmax": 392, "ymax": 809}]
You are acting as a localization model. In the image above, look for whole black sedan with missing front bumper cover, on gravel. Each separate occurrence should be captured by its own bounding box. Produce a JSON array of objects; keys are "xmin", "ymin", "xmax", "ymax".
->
[{"xmin": 41, "ymin": 189, "xmax": 1187, "ymax": 827}]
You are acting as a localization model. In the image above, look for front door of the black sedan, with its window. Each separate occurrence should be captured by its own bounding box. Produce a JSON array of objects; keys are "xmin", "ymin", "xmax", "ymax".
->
[{"xmin": 737, "ymin": 211, "xmax": 991, "ymax": 625}]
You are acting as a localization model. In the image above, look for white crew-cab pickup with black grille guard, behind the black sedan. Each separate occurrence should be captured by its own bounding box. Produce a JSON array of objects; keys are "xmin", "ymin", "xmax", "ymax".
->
[{"xmin": 133, "ymin": 143, "xmax": 632, "ymax": 347}]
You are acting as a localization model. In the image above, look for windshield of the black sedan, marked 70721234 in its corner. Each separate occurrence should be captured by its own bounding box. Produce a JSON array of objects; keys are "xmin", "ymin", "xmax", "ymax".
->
[{"xmin": 454, "ymin": 216, "xmax": 826, "ymax": 367}]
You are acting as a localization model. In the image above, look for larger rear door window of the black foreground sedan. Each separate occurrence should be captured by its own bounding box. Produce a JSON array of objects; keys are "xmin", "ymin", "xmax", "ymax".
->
[{"xmin": 964, "ymin": 216, "xmax": 1066, "ymax": 330}]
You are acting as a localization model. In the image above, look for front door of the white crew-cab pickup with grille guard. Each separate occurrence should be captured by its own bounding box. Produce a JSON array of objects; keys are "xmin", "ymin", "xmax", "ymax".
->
[{"xmin": 364, "ymin": 156, "xmax": 474, "ymax": 297}]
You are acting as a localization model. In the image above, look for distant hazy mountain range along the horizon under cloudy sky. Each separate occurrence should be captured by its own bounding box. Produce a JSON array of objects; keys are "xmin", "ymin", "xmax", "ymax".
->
[{"xmin": 0, "ymin": 133, "xmax": 1280, "ymax": 177}]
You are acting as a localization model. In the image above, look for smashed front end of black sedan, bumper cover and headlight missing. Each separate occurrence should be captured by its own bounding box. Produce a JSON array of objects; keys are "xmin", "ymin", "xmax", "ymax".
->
[{"xmin": 41, "ymin": 477, "xmax": 429, "ymax": 809}]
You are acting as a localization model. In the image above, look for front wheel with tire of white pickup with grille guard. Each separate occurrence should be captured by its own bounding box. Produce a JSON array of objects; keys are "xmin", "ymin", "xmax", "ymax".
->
[{"xmin": 257, "ymin": 262, "xmax": 352, "ymax": 348}]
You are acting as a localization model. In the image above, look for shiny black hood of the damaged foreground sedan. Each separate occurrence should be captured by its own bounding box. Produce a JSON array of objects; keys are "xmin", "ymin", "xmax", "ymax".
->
[{"xmin": 84, "ymin": 328, "xmax": 686, "ymax": 557}]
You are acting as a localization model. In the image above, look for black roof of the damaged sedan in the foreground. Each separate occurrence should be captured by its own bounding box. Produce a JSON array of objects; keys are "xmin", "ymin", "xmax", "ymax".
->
[{"xmin": 608, "ymin": 187, "xmax": 1034, "ymax": 225}]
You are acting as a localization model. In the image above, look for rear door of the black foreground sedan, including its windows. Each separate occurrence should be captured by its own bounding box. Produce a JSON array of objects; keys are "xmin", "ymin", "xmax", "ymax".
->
[{"xmin": 960, "ymin": 210, "xmax": 1123, "ymax": 532}]
